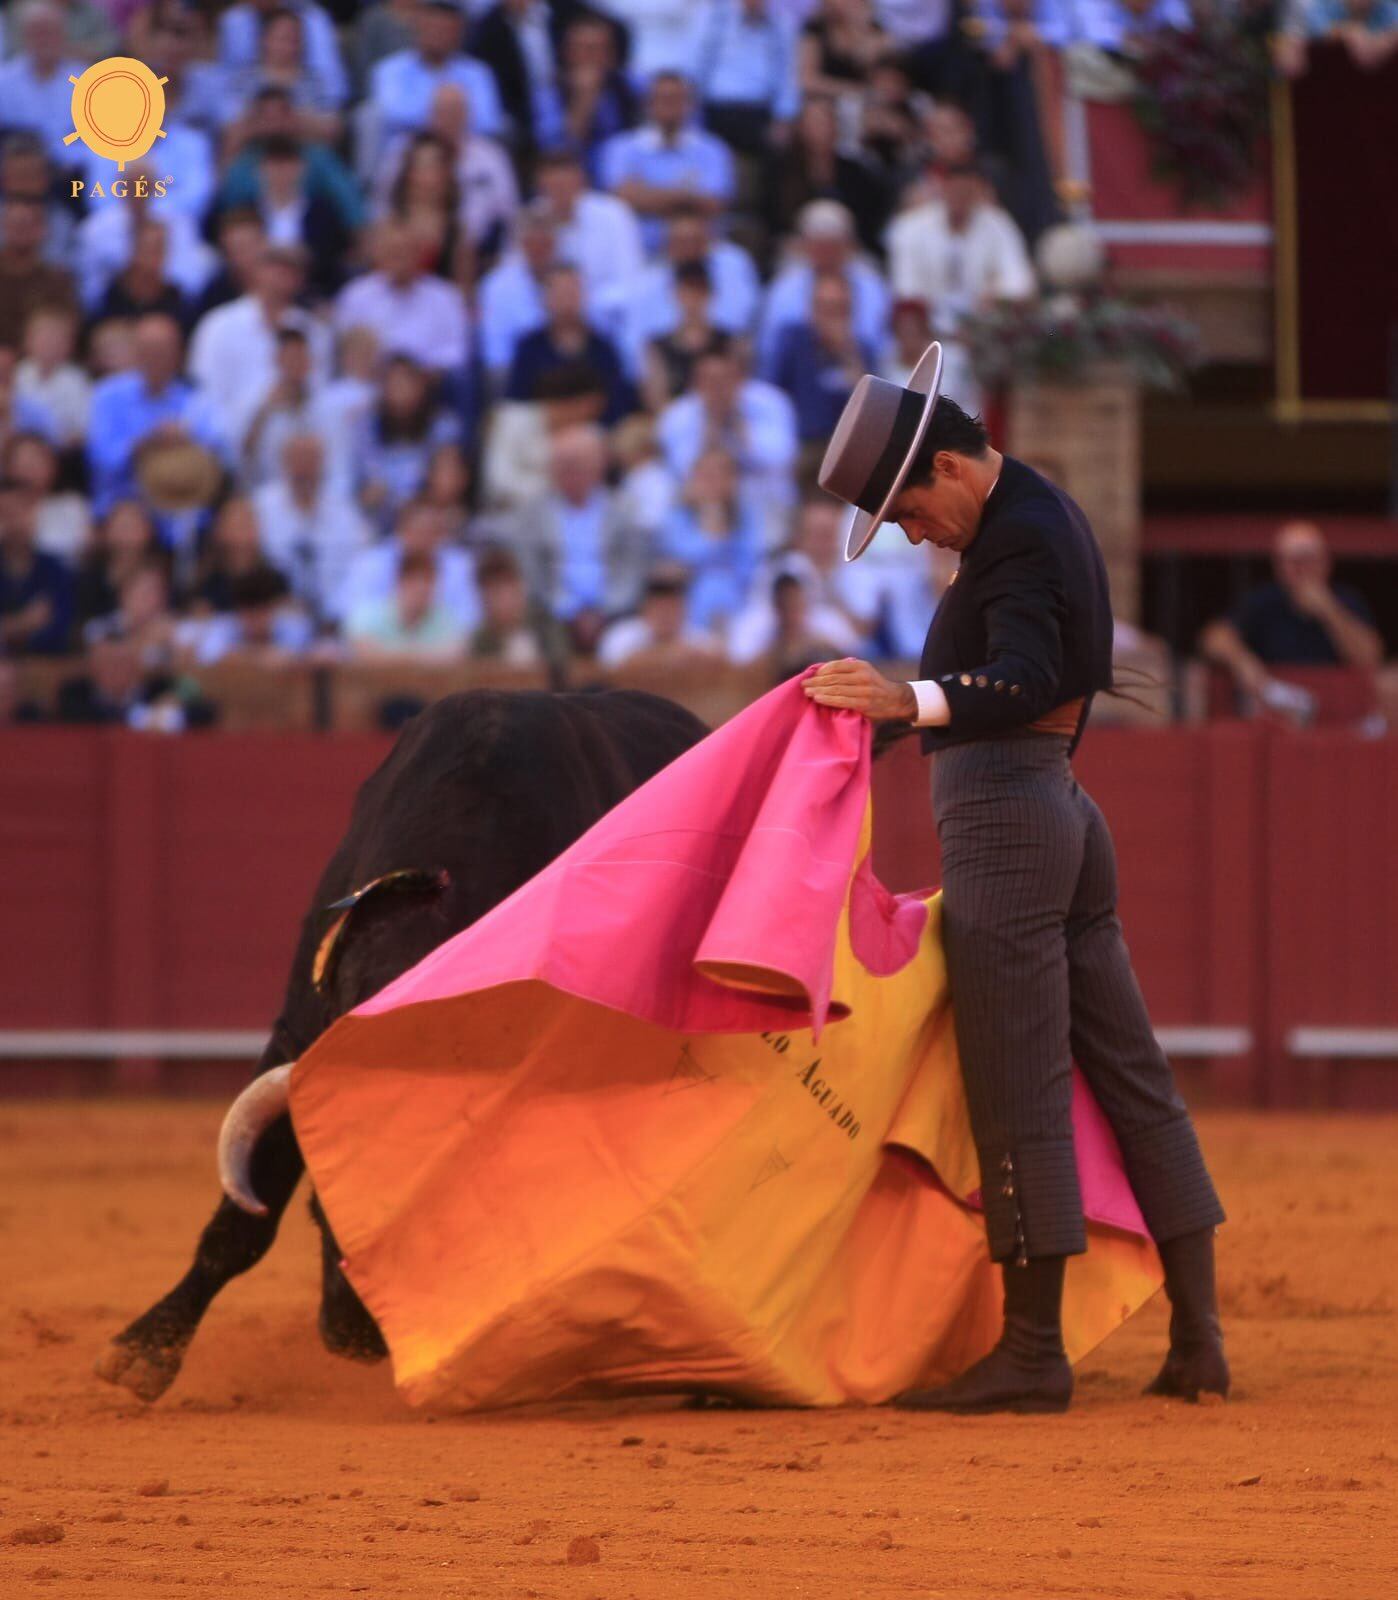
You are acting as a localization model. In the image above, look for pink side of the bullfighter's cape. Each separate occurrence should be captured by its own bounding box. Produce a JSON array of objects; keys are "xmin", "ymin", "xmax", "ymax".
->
[{"xmin": 345, "ymin": 678, "xmax": 1145, "ymax": 1237}]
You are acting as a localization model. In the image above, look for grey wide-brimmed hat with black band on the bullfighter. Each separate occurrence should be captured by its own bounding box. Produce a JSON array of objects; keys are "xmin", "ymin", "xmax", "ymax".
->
[{"xmin": 819, "ymin": 339, "xmax": 942, "ymax": 562}]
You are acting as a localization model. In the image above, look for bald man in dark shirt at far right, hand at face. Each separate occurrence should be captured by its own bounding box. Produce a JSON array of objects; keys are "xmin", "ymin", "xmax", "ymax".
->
[{"xmin": 1200, "ymin": 522, "xmax": 1384, "ymax": 722}]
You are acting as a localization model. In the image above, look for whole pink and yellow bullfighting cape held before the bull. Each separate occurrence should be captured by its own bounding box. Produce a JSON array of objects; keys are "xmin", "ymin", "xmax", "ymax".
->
[{"xmin": 291, "ymin": 680, "xmax": 1160, "ymax": 1406}]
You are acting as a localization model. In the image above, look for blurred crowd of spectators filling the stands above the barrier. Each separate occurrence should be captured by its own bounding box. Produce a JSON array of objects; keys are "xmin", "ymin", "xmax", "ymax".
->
[{"xmin": 0, "ymin": 0, "xmax": 1398, "ymax": 726}]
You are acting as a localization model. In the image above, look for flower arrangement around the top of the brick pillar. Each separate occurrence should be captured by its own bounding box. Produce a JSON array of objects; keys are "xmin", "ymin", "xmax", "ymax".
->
[{"xmin": 957, "ymin": 294, "xmax": 1200, "ymax": 389}]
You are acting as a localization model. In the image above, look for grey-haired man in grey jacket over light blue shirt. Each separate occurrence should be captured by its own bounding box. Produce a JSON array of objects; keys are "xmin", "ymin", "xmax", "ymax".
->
[{"xmin": 512, "ymin": 427, "xmax": 648, "ymax": 651}]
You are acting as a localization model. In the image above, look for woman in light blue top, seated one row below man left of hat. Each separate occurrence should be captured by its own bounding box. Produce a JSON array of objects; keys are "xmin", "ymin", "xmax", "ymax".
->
[{"xmin": 659, "ymin": 445, "xmax": 763, "ymax": 630}]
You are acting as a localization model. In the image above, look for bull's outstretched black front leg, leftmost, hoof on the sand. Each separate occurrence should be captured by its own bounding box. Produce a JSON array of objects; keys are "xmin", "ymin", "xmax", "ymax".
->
[{"xmin": 98, "ymin": 1117, "xmax": 306, "ymax": 1400}]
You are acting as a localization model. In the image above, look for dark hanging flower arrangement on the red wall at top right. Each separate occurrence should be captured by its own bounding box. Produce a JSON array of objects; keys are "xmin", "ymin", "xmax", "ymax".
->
[{"xmin": 1132, "ymin": 21, "xmax": 1268, "ymax": 208}]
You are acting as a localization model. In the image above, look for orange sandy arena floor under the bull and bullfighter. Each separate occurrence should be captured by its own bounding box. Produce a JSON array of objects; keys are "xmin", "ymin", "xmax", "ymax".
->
[{"xmin": 0, "ymin": 1102, "xmax": 1398, "ymax": 1600}]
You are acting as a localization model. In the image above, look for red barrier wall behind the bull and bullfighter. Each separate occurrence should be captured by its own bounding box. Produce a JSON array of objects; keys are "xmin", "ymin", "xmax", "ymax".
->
[{"xmin": 0, "ymin": 723, "xmax": 1398, "ymax": 1102}]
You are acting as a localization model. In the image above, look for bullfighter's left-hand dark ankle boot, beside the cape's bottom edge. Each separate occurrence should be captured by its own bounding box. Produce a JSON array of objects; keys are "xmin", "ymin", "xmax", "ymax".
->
[{"xmin": 893, "ymin": 1256, "xmax": 1073, "ymax": 1413}]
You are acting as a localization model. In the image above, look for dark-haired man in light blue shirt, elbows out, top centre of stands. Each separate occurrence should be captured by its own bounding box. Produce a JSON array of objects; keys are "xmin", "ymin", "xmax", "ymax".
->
[{"xmin": 598, "ymin": 64, "xmax": 734, "ymax": 251}]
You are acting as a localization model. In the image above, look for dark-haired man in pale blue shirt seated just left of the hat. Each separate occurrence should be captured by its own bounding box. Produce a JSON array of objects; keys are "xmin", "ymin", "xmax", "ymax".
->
[{"xmin": 656, "ymin": 342, "xmax": 797, "ymax": 534}]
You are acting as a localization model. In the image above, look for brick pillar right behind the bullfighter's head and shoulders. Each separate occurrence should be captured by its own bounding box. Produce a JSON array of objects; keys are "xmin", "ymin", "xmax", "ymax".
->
[{"xmin": 1008, "ymin": 366, "xmax": 1140, "ymax": 622}]
